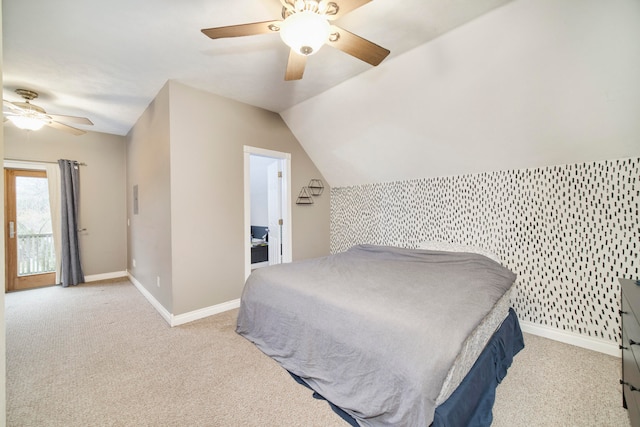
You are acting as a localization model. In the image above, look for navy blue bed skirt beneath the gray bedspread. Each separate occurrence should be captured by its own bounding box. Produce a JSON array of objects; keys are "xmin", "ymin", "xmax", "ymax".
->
[{"xmin": 290, "ymin": 308, "xmax": 524, "ymax": 427}]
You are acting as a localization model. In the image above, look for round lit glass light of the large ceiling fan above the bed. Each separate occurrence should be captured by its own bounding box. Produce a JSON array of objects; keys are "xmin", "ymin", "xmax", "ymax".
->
[{"xmin": 280, "ymin": 10, "xmax": 331, "ymax": 56}]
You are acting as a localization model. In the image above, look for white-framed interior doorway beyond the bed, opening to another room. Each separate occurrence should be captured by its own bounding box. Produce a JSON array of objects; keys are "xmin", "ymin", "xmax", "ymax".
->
[{"xmin": 244, "ymin": 146, "xmax": 291, "ymax": 279}]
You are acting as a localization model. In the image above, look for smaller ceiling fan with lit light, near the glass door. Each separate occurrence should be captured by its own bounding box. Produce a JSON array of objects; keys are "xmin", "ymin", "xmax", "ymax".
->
[{"xmin": 2, "ymin": 89, "xmax": 93, "ymax": 135}]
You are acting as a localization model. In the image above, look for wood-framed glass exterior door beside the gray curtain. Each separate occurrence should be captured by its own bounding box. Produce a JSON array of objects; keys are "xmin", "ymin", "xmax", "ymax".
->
[{"xmin": 5, "ymin": 169, "xmax": 56, "ymax": 292}]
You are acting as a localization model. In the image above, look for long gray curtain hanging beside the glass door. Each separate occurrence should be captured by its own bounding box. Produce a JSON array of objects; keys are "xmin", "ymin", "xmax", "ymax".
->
[{"xmin": 58, "ymin": 160, "xmax": 84, "ymax": 287}]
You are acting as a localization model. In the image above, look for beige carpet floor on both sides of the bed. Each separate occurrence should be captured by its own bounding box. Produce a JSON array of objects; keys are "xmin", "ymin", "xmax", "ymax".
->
[{"xmin": 5, "ymin": 282, "xmax": 629, "ymax": 427}]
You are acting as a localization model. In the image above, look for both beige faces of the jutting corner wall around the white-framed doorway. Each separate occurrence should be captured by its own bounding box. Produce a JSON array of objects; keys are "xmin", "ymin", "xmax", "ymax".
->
[{"xmin": 127, "ymin": 82, "xmax": 329, "ymax": 315}]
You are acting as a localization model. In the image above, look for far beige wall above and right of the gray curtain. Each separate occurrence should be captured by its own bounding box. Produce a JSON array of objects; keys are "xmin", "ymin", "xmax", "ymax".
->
[{"xmin": 4, "ymin": 124, "xmax": 127, "ymax": 276}]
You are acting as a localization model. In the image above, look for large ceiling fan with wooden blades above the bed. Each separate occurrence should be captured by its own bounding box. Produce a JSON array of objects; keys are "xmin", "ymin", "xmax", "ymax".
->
[{"xmin": 202, "ymin": 0, "xmax": 389, "ymax": 80}]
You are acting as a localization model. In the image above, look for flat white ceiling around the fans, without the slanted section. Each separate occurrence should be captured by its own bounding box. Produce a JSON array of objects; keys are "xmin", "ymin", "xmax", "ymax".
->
[{"xmin": 2, "ymin": 0, "xmax": 510, "ymax": 135}]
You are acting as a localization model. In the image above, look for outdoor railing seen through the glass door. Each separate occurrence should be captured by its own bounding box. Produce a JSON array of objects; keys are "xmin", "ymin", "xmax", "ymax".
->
[{"xmin": 18, "ymin": 233, "xmax": 56, "ymax": 276}]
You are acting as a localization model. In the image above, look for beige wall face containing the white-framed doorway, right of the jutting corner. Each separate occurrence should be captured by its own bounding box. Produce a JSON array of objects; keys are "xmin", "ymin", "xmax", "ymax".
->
[{"xmin": 170, "ymin": 82, "xmax": 329, "ymax": 313}]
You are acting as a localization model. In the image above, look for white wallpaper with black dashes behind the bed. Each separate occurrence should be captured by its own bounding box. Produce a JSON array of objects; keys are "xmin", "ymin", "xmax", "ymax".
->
[{"xmin": 331, "ymin": 158, "xmax": 640, "ymax": 342}]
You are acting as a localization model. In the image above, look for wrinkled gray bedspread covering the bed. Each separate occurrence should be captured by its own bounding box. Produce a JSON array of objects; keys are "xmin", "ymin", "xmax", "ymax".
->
[{"xmin": 237, "ymin": 245, "xmax": 515, "ymax": 426}]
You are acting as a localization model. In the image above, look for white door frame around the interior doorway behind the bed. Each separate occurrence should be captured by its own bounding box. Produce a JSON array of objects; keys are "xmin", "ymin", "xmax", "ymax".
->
[{"xmin": 244, "ymin": 145, "xmax": 292, "ymax": 280}]
